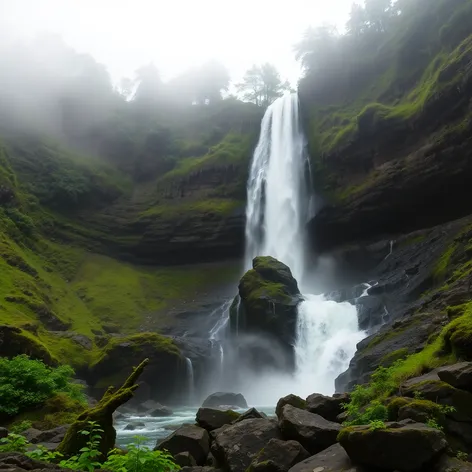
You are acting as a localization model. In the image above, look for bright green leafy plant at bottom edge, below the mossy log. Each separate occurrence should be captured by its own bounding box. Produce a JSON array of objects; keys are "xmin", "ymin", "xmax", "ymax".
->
[{"xmin": 102, "ymin": 436, "xmax": 179, "ymax": 472}]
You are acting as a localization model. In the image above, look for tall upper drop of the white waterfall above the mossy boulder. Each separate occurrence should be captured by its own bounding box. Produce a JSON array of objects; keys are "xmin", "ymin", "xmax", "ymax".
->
[{"xmin": 245, "ymin": 94, "xmax": 310, "ymax": 281}]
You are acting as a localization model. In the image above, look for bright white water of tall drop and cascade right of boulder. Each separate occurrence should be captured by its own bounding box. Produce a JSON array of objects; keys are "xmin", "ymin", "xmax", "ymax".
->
[{"xmin": 241, "ymin": 94, "xmax": 369, "ymax": 404}]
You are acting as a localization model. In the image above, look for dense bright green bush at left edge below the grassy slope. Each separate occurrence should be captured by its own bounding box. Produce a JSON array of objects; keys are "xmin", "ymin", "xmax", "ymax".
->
[{"xmin": 0, "ymin": 355, "xmax": 83, "ymax": 416}]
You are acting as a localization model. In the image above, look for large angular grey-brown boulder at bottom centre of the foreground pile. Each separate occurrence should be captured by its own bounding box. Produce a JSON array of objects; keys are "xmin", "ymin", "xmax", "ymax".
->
[{"xmin": 211, "ymin": 418, "xmax": 280, "ymax": 472}]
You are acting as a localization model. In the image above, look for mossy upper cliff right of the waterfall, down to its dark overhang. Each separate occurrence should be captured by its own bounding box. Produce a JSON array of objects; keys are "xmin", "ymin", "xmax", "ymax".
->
[{"xmin": 299, "ymin": 0, "xmax": 472, "ymax": 250}]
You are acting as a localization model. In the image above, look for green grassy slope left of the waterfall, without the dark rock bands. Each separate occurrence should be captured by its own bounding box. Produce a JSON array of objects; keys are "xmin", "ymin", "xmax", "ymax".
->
[{"xmin": 0, "ymin": 103, "xmax": 252, "ymax": 367}]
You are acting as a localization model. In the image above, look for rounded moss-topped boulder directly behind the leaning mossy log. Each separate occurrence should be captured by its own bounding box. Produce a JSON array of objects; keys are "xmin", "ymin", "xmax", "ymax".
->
[{"xmin": 88, "ymin": 333, "xmax": 186, "ymax": 403}]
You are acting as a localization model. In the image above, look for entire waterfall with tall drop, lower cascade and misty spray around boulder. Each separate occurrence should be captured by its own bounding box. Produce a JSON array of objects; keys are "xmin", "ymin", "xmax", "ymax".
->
[{"xmin": 207, "ymin": 94, "xmax": 365, "ymax": 406}]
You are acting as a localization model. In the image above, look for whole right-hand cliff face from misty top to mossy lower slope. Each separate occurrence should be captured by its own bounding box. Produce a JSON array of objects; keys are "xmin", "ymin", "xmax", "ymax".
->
[{"xmin": 300, "ymin": 0, "xmax": 472, "ymax": 400}]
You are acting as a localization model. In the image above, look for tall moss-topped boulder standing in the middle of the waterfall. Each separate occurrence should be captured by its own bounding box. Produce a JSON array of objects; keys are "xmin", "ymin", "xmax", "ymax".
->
[{"xmin": 230, "ymin": 256, "xmax": 302, "ymax": 364}]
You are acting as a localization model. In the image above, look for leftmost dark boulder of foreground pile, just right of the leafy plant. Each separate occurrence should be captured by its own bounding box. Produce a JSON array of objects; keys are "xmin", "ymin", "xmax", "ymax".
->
[{"xmin": 155, "ymin": 425, "xmax": 210, "ymax": 465}]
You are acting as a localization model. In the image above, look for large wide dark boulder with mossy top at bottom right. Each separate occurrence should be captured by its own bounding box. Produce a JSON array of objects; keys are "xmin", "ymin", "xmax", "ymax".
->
[{"xmin": 338, "ymin": 423, "xmax": 447, "ymax": 472}]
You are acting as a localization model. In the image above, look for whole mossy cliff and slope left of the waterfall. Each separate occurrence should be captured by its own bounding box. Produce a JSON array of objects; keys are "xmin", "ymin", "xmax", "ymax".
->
[{"xmin": 0, "ymin": 97, "xmax": 260, "ymax": 401}]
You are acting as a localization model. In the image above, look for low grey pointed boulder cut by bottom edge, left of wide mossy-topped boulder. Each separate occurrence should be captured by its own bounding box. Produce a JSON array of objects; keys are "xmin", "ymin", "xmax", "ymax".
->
[{"xmin": 289, "ymin": 444, "xmax": 367, "ymax": 472}]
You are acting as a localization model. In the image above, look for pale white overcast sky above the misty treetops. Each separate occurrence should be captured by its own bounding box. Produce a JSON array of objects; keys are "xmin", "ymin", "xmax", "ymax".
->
[{"xmin": 0, "ymin": 0, "xmax": 353, "ymax": 84}]
